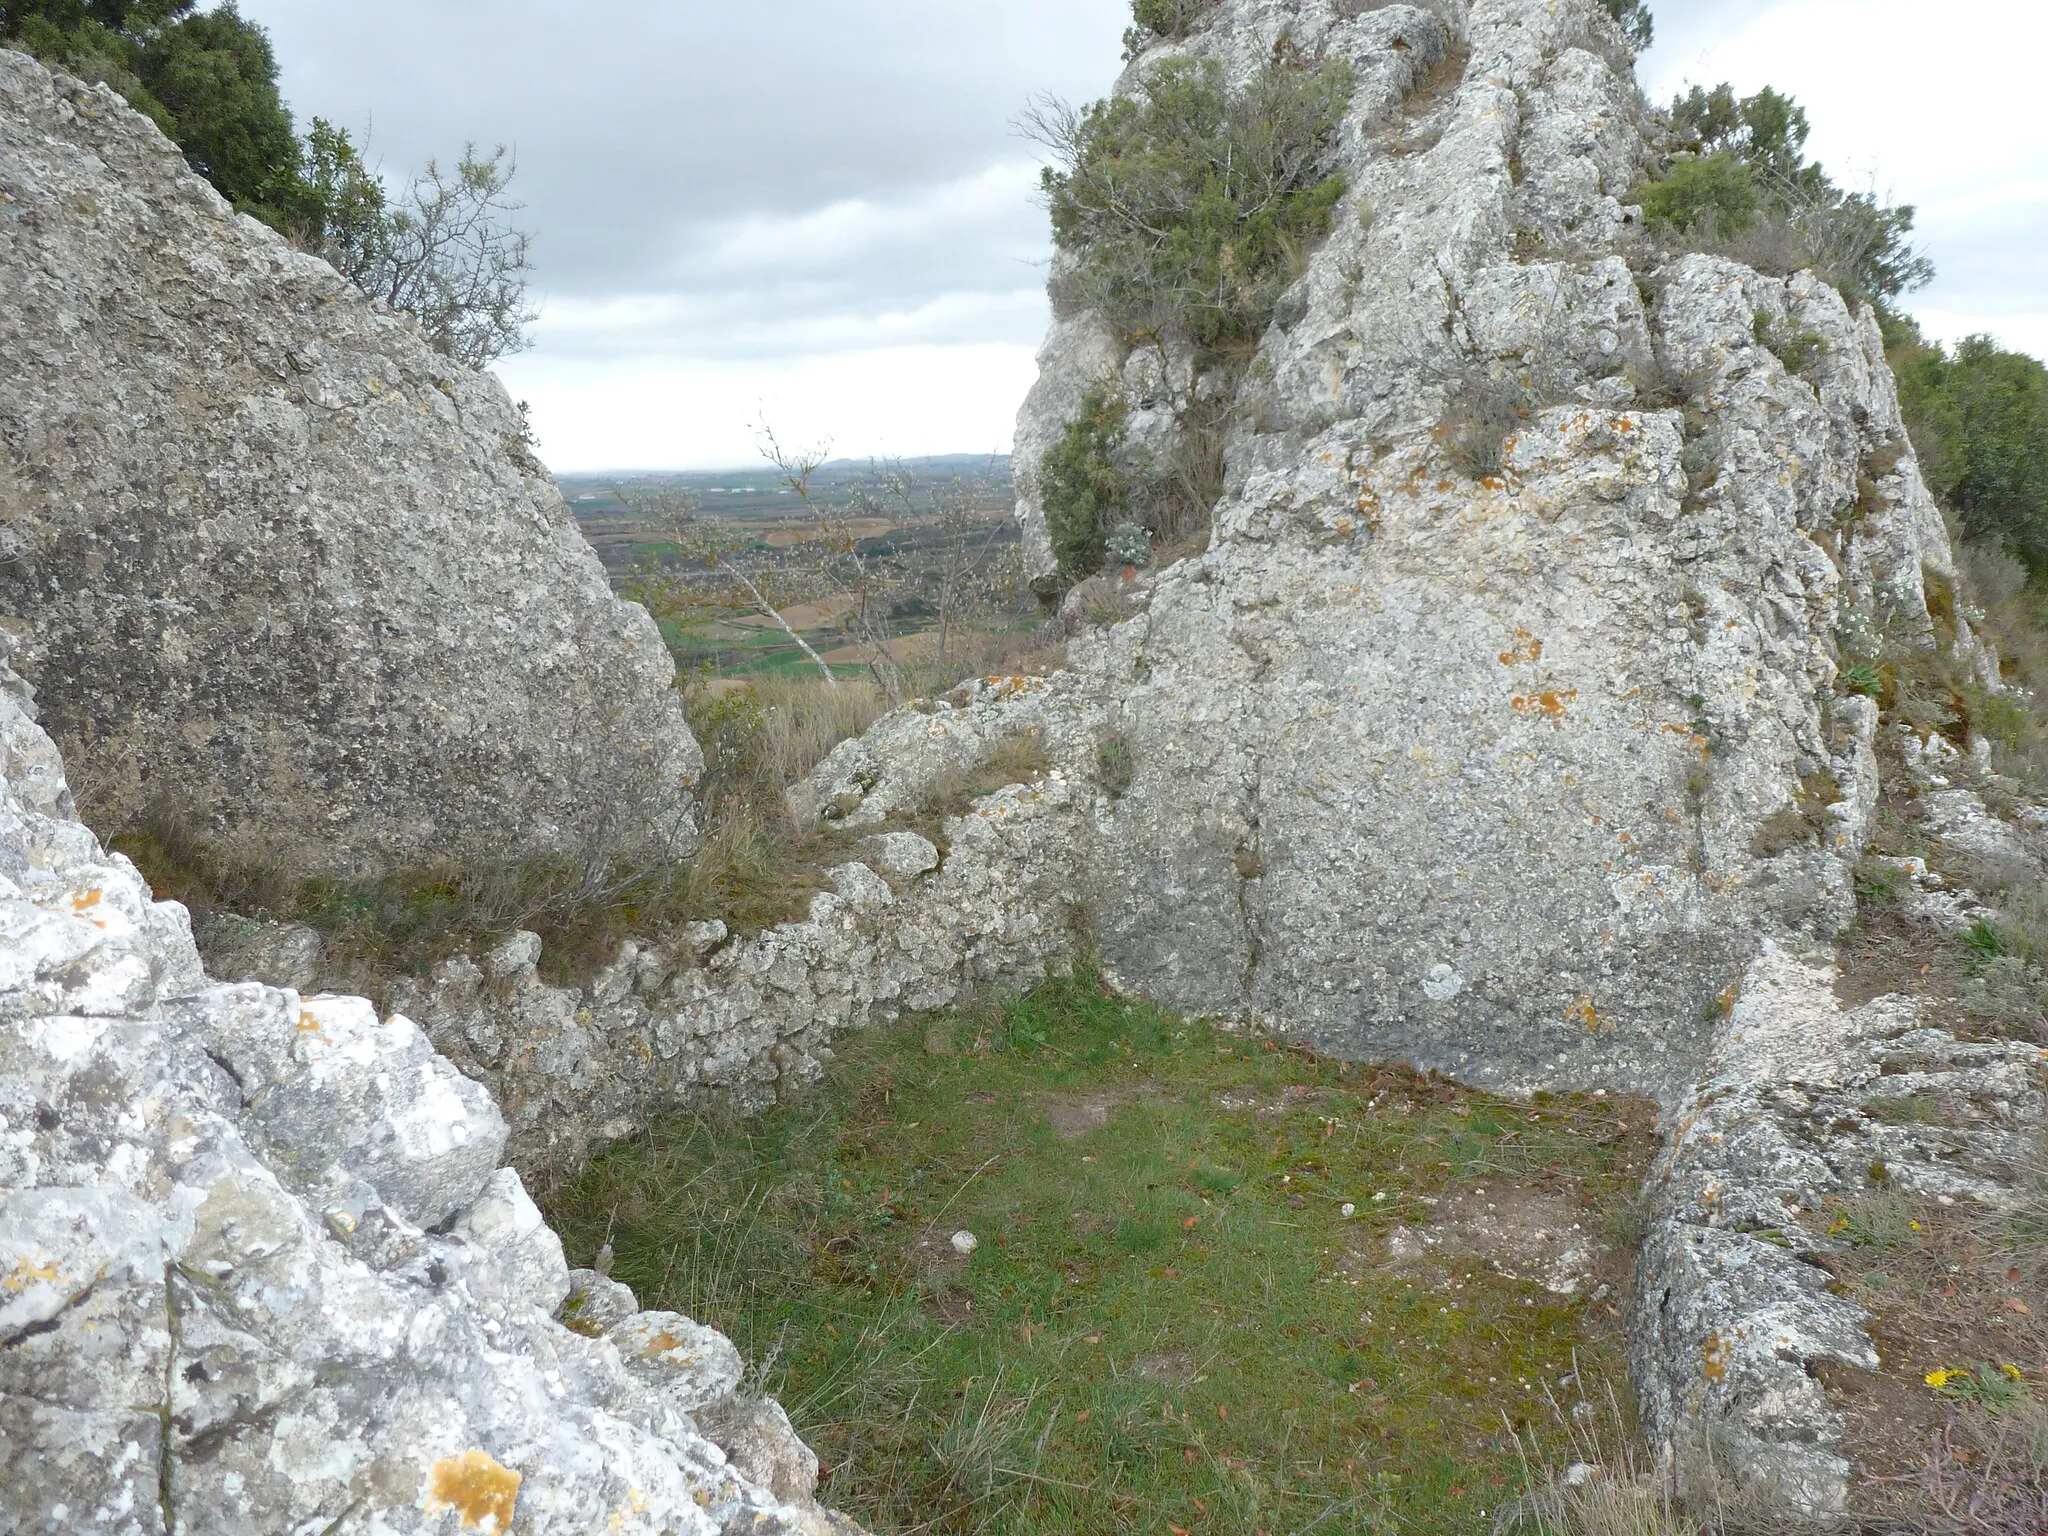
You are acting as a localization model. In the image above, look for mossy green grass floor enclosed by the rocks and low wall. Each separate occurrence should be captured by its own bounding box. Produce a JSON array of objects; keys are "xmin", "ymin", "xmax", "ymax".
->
[{"xmin": 549, "ymin": 973, "xmax": 1653, "ymax": 1536}]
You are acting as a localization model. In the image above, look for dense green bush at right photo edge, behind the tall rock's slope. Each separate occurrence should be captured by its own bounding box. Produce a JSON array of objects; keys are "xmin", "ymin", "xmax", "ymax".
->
[{"xmin": 1892, "ymin": 331, "xmax": 2048, "ymax": 578}]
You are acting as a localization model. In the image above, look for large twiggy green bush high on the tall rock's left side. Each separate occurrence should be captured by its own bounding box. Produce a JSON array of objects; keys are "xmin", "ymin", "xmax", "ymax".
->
[{"xmin": 1034, "ymin": 59, "xmax": 1352, "ymax": 356}]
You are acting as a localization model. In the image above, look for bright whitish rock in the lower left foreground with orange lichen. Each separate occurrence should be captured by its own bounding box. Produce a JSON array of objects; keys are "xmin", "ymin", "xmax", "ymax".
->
[{"xmin": 0, "ymin": 643, "xmax": 854, "ymax": 1536}]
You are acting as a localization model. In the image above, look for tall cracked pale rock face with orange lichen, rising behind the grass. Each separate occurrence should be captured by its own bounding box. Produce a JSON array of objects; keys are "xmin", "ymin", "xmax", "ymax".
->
[{"xmin": 805, "ymin": 0, "xmax": 1950, "ymax": 1104}]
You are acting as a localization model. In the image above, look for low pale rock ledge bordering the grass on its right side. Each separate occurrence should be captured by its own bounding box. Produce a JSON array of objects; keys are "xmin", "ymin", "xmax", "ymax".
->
[{"xmin": 1630, "ymin": 944, "xmax": 2048, "ymax": 1511}]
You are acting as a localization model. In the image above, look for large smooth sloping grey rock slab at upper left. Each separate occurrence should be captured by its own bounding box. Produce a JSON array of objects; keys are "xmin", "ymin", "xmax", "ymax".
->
[{"xmin": 0, "ymin": 53, "xmax": 702, "ymax": 877}]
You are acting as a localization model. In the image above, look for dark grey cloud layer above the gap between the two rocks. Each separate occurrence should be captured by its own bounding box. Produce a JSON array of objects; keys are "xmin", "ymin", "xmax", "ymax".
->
[{"xmin": 242, "ymin": 0, "xmax": 1128, "ymax": 297}]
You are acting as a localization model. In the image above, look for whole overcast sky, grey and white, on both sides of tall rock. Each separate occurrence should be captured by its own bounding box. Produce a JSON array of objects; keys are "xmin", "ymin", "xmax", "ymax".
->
[{"xmin": 242, "ymin": 0, "xmax": 2048, "ymax": 471}]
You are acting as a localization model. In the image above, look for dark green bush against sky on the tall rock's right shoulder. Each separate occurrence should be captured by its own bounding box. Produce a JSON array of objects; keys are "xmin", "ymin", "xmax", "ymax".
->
[{"xmin": 1634, "ymin": 84, "xmax": 1933, "ymax": 301}]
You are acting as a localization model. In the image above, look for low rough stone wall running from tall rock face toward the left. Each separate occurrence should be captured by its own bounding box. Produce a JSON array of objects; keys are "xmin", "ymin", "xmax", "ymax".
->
[{"xmin": 209, "ymin": 678, "xmax": 1094, "ymax": 1180}]
